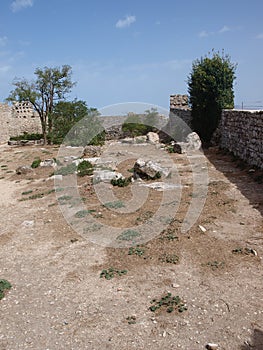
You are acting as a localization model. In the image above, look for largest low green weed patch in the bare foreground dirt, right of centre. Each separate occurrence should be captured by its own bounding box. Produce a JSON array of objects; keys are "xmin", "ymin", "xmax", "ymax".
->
[{"xmin": 149, "ymin": 293, "xmax": 187, "ymax": 313}]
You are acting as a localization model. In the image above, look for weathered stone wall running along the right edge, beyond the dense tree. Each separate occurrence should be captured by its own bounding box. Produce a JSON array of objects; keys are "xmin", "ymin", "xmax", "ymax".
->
[{"xmin": 220, "ymin": 110, "xmax": 263, "ymax": 169}]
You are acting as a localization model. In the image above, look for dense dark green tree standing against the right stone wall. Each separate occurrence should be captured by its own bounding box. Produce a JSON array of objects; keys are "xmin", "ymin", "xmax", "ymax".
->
[{"xmin": 188, "ymin": 52, "xmax": 236, "ymax": 143}]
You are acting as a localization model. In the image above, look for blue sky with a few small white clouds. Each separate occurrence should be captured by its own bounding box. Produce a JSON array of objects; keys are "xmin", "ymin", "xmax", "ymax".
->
[{"xmin": 0, "ymin": 0, "xmax": 263, "ymax": 108}]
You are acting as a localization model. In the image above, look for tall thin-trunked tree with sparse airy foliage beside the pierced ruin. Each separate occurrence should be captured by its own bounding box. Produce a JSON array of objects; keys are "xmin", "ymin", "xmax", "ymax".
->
[{"xmin": 7, "ymin": 65, "xmax": 75, "ymax": 143}]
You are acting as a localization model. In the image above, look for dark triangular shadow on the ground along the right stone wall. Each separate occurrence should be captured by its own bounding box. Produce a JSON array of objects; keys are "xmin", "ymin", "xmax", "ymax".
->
[{"xmin": 204, "ymin": 148, "xmax": 263, "ymax": 219}]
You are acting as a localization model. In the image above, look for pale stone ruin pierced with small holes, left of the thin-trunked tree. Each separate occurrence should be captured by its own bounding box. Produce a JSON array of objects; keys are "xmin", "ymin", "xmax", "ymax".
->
[{"xmin": 0, "ymin": 102, "xmax": 42, "ymax": 143}]
